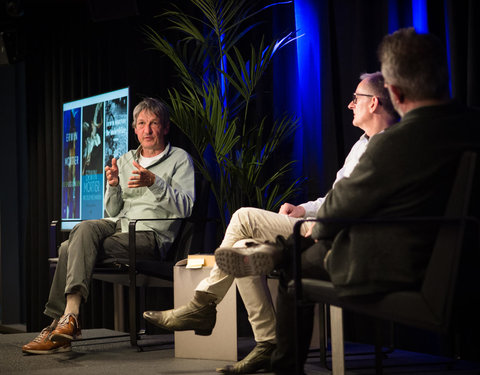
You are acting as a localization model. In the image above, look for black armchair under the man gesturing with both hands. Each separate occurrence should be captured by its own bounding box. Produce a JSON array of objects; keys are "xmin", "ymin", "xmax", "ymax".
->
[{"xmin": 49, "ymin": 173, "xmax": 213, "ymax": 349}]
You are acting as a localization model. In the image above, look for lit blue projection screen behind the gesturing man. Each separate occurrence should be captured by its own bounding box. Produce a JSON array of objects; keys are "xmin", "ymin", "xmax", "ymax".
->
[{"xmin": 61, "ymin": 88, "xmax": 129, "ymax": 229}]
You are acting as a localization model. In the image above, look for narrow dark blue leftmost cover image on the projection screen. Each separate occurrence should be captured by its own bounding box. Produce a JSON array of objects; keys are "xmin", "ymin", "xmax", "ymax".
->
[{"xmin": 62, "ymin": 108, "xmax": 81, "ymax": 219}]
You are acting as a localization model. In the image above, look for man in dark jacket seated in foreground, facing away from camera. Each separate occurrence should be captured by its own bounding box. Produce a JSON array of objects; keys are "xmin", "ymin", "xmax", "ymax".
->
[{"xmin": 215, "ymin": 28, "xmax": 480, "ymax": 374}]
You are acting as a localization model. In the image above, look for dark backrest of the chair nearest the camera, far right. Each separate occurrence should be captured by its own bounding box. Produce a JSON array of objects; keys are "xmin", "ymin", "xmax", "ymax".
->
[{"xmin": 422, "ymin": 152, "xmax": 477, "ymax": 324}]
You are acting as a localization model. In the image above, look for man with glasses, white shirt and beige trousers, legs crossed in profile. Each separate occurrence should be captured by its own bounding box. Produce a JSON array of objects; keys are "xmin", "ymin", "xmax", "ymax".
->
[{"xmin": 144, "ymin": 72, "xmax": 398, "ymax": 374}]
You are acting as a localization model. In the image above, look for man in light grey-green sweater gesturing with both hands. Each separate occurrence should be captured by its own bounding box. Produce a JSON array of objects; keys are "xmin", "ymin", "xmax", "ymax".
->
[{"xmin": 22, "ymin": 98, "xmax": 195, "ymax": 354}]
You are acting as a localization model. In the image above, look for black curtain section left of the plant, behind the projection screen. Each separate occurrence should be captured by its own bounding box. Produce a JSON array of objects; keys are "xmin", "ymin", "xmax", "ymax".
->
[{"xmin": 25, "ymin": 2, "xmax": 188, "ymax": 331}]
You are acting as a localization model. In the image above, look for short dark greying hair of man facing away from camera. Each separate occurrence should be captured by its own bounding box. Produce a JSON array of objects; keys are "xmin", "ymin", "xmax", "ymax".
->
[{"xmin": 378, "ymin": 27, "xmax": 449, "ymax": 100}]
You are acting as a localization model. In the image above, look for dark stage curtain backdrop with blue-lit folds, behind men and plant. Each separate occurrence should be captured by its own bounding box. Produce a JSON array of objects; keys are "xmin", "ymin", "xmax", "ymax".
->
[{"xmin": 4, "ymin": 0, "xmax": 480, "ymax": 360}]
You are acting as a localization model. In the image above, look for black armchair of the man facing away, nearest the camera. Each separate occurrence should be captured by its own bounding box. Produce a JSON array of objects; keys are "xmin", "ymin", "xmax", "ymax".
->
[{"xmin": 293, "ymin": 152, "xmax": 479, "ymax": 375}]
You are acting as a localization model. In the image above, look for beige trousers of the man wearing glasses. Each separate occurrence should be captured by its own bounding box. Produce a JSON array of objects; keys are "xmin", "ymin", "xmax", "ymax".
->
[{"xmin": 196, "ymin": 207, "xmax": 306, "ymax": 342}]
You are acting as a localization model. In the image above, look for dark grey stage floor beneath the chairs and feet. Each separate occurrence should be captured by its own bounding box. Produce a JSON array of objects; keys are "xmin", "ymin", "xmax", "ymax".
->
[{"xmin": 0, "ymin": 329, "xmax": 480, "ymax": 375}]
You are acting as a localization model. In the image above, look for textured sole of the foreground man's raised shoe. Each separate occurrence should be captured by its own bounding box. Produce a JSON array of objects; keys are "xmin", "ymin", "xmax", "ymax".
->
[{"xmin": 215, "ymin": 248, "xmax": 275, "ymax": 277}]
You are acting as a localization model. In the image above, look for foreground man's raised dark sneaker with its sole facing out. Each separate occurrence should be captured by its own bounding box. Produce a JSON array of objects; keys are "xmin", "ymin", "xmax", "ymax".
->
[{"xmin": 215, "ymin": 243, "xmax": 282, "ymax": 277}]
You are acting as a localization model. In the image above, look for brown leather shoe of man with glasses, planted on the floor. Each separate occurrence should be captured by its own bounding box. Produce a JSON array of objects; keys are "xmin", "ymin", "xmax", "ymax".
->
[{"xmin": 217, "ymin": 342, "xmax": 276, "ymax": 374}]
